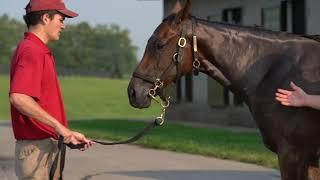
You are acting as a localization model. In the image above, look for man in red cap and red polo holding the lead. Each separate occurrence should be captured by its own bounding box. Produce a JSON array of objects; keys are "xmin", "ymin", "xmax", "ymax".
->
[{"xmin": 9, "ymin": 0, "xmax": 93, "ymax": 180}]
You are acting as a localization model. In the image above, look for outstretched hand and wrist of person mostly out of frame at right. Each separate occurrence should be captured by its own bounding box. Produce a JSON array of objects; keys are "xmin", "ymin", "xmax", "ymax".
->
[{"xmin": 276, "ymin": 82, "xmax": 320, "ymax": 110}]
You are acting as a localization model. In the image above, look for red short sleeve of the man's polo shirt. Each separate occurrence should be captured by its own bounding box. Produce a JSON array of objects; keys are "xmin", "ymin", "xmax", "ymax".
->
[{"xmin": 10, "ymin": 48, "xmax": 44, "ymax": 100}]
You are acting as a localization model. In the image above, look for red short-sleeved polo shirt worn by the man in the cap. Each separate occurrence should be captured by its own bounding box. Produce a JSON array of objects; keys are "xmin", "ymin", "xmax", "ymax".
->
[{"xmin": 10, "ymin": 32, "xmax": 67, "ymax": 140}]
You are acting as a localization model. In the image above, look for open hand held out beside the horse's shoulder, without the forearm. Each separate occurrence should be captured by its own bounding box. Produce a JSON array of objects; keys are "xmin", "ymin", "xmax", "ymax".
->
[{"xmin": 276, "ymin": 82, "xmax": 308, "ymax": 107}]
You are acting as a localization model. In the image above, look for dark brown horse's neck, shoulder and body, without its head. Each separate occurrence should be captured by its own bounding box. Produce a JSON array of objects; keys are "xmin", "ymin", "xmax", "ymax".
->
[{"xmin": 197, "ymin": 20, "xmax": 320, "ymax": 180}]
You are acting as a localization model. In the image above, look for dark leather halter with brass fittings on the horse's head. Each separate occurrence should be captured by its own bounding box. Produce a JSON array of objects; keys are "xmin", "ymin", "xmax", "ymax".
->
[{"xmin": 132, "ymin": 17, "xmax": 200, "ymax": 96}]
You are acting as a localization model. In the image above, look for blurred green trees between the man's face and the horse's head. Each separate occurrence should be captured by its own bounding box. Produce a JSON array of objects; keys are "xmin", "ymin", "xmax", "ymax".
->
[{"xmin": 51, "ymin": 22, "xmax": 137, "ymax": 78}]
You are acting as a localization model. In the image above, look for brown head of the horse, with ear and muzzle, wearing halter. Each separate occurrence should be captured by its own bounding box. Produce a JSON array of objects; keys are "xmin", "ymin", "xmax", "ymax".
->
[{"xmin": 128, "ymin": 0, "xmax": 192, "ymax": 108}]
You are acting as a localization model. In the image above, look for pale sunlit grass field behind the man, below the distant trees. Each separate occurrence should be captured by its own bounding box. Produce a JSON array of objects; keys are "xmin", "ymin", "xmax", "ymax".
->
[{"xmin": 0, "ymin": 75, "xmax": 160, "ymax": 120}]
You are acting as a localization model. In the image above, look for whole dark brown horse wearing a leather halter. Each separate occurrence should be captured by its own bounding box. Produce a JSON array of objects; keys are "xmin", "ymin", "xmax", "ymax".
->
[{"xmin": 127, "ymin": 0, "xmax": 320, "ymax": 180}]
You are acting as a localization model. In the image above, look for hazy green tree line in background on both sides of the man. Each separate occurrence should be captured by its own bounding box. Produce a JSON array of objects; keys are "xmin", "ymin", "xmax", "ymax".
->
[{"xmin": 0, "ymin": 15, "xmax": 137, "ymax": 78}]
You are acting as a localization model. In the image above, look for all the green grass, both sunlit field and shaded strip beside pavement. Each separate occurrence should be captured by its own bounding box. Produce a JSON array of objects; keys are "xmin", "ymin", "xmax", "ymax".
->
[{"xmin": 0, "ymin": 75, "xmax": 278, "ymax": 168}]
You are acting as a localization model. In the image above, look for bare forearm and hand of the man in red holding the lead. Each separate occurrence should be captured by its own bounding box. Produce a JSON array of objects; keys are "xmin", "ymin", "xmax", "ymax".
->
[{"xmin": 10, "ymin": 93, "xmax": 92, "ymax": 146}]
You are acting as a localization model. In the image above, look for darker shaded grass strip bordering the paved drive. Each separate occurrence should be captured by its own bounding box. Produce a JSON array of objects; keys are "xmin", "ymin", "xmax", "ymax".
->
[{"xmin": 70, "ymin": 120, "xmax": 278, "ymax": 168}]
